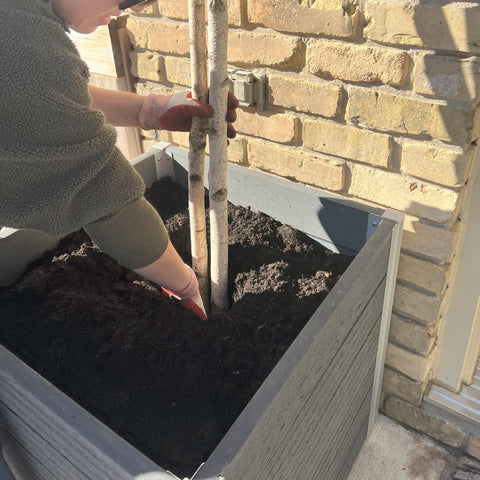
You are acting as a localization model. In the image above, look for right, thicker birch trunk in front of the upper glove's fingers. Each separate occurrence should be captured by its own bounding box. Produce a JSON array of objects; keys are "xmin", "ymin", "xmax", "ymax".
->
[{"xmin": 208, "ymin": 0, "xmax": 228, "ymax": 310}]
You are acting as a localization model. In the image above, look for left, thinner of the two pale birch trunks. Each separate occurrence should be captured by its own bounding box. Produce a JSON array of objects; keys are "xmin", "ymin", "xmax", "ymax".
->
[{"xmin": 188, "ymin": 0, "xmax": 210, "ymax": 304}]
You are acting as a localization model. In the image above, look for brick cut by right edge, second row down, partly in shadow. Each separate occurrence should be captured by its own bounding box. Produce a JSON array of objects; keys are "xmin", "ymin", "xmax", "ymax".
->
[{"xmin": 413, "ymin": 53, "xmax": 480, "ymax": 102}]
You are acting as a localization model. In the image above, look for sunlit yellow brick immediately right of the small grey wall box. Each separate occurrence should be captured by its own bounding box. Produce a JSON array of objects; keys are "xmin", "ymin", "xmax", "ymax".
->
[{"xmin": 267, "ymin": 74, "xmax": 343, "ymax": 117}]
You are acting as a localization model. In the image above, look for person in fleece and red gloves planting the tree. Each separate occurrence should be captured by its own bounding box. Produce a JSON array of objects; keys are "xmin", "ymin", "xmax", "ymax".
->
[{"xmin": 0, "ymin": 0, "xmax": 238, "ymax": 319}]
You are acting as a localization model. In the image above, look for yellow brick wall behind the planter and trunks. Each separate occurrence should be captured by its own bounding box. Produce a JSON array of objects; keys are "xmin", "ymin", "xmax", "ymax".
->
[{"xmin": 128, "ymin": 0, "xmax": 480, "ymax": 428}]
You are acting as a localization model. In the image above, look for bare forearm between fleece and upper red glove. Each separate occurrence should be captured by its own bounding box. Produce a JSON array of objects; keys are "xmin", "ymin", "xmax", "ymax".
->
[{"xmin": 88, "ymin": 85, "xmax": 145, "ymax": 127}]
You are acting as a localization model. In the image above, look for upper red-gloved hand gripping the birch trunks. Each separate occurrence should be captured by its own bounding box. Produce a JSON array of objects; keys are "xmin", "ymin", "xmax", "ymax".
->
[{"xmin": 138, "ymin": 90, "xmax": 238, "ymax": 138}]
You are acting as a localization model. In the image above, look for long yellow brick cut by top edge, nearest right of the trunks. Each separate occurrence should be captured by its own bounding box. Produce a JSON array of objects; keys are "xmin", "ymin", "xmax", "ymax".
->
[{"xmin": 248, "ymin": 0, "xmax": 357, "ymax": 38}]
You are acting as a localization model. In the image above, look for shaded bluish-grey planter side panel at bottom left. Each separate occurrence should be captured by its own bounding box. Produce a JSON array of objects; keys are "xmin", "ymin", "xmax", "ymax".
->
[{"xmin": 0, "ymin": 346, "xmax": 172, "ymax": 480}]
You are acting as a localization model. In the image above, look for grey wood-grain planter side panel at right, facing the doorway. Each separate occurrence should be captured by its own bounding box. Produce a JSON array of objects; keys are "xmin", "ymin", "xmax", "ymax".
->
[{"xmin": 196, "ymin": 221, "xmax": 392, "ymax": 480}]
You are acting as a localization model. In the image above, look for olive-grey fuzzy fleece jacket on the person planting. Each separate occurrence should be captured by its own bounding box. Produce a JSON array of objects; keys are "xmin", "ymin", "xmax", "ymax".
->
[{"xmin": 0, "ymin": 0, "xmax": 144, "ymax": 235}]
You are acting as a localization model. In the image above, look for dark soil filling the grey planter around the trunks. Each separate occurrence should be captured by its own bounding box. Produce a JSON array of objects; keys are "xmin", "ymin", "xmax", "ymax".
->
[{"xmin": 0, "ymin": 179, "xmax": 351, "ymax": 476}]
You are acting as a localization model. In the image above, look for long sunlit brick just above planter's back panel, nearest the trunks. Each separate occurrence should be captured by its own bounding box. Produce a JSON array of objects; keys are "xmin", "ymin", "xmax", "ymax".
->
[{"xmin": 248, "ymin": 140, "xmax": 345, "ymax": 191}]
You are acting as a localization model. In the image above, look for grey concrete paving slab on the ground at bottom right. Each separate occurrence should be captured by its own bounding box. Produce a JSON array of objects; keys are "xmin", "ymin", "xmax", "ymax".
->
[{"xmin": 348, "ymin": 415, "xmax": 458, "ymax": 480}]
